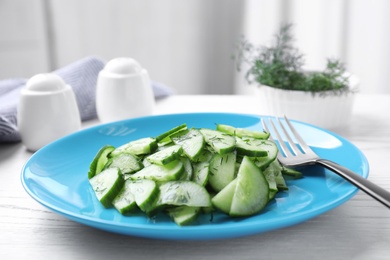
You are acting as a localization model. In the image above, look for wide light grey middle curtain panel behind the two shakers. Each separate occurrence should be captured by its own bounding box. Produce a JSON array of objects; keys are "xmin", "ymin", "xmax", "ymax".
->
[{"xmin": 43, "ymin": 0, "xmax": 244, "ymax": 94}]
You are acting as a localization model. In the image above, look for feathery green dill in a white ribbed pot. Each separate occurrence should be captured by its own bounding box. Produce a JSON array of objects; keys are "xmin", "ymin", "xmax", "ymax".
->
[{"xmin": 235, "ymin": 24, "xmax": 359, "ymax": 129}]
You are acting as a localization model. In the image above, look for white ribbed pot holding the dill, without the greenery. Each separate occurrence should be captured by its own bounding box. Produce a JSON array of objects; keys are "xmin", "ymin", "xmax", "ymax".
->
[{"xmin": 255, "ymin": 76, "xmax": 359, "ymax": 130}]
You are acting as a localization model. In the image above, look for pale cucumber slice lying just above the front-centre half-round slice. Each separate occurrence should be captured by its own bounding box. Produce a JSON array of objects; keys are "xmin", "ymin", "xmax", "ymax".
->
[{"xmin": 126, "ymin": 160, "xmax": 184, "ymax": 182}]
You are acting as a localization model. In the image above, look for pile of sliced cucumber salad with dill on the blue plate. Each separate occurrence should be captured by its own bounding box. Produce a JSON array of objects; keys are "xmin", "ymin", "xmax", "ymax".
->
[{"xmin": 88, "ymin": 124, "xmax": 302, "ymax": 226}]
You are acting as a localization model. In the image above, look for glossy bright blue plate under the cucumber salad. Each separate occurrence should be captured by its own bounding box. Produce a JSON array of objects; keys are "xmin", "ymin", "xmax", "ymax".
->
[{"xmin": 21, "ymin": 113, "xmax": 368, "ymax": 239}]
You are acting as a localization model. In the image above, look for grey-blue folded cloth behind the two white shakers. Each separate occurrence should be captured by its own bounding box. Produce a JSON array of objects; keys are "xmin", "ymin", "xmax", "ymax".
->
[{"xmin": 0, "ymin": 57, "xmax": 173, "ymax": 143}]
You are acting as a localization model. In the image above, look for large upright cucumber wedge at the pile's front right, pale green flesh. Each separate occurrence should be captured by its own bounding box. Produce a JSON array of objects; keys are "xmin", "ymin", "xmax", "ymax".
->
[{"xmin": 229, "ymin": 156, "xmax": 269, "ymax": 217}]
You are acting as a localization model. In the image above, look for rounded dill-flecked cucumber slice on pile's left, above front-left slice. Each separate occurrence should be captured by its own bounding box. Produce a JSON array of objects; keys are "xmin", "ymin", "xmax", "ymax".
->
[{"xmin": 105, "ymin": 153, "xmax": 144, "ymax": 174}]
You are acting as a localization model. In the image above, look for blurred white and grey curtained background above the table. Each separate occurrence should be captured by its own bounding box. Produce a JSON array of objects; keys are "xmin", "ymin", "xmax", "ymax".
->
[{"xmin": 0, "ymin": 0, "xmax": 390, "ymax": 94}]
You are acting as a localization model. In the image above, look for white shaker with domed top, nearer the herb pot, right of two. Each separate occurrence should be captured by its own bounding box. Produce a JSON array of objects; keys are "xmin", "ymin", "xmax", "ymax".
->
[{"xmin": 96, "ymin": 57, "xmax": 155, "ymax": 123}]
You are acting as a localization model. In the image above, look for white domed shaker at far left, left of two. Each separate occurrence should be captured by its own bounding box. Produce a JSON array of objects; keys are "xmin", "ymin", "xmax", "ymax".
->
[{"xmin": 17, "ymin": 73, "xmax": 81, "ymax": 151}]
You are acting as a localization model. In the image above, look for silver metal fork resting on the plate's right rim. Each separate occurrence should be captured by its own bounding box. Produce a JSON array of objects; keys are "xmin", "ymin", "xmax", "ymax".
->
[{"xmin": 262, "ymin": 116, "xmax": 390, "ymax": 208}]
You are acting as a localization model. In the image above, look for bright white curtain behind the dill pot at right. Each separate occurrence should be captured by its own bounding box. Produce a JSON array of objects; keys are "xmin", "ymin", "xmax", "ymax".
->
[{"xmin": 236, "ymin": 0, "xmax": 390, "ymax": 93}]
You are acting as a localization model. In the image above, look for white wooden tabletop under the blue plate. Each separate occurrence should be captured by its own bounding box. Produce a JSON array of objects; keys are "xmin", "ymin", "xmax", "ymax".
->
[{"xmin": 0, "ymin": 95, "xmax": 390, "ymax": 260}]
